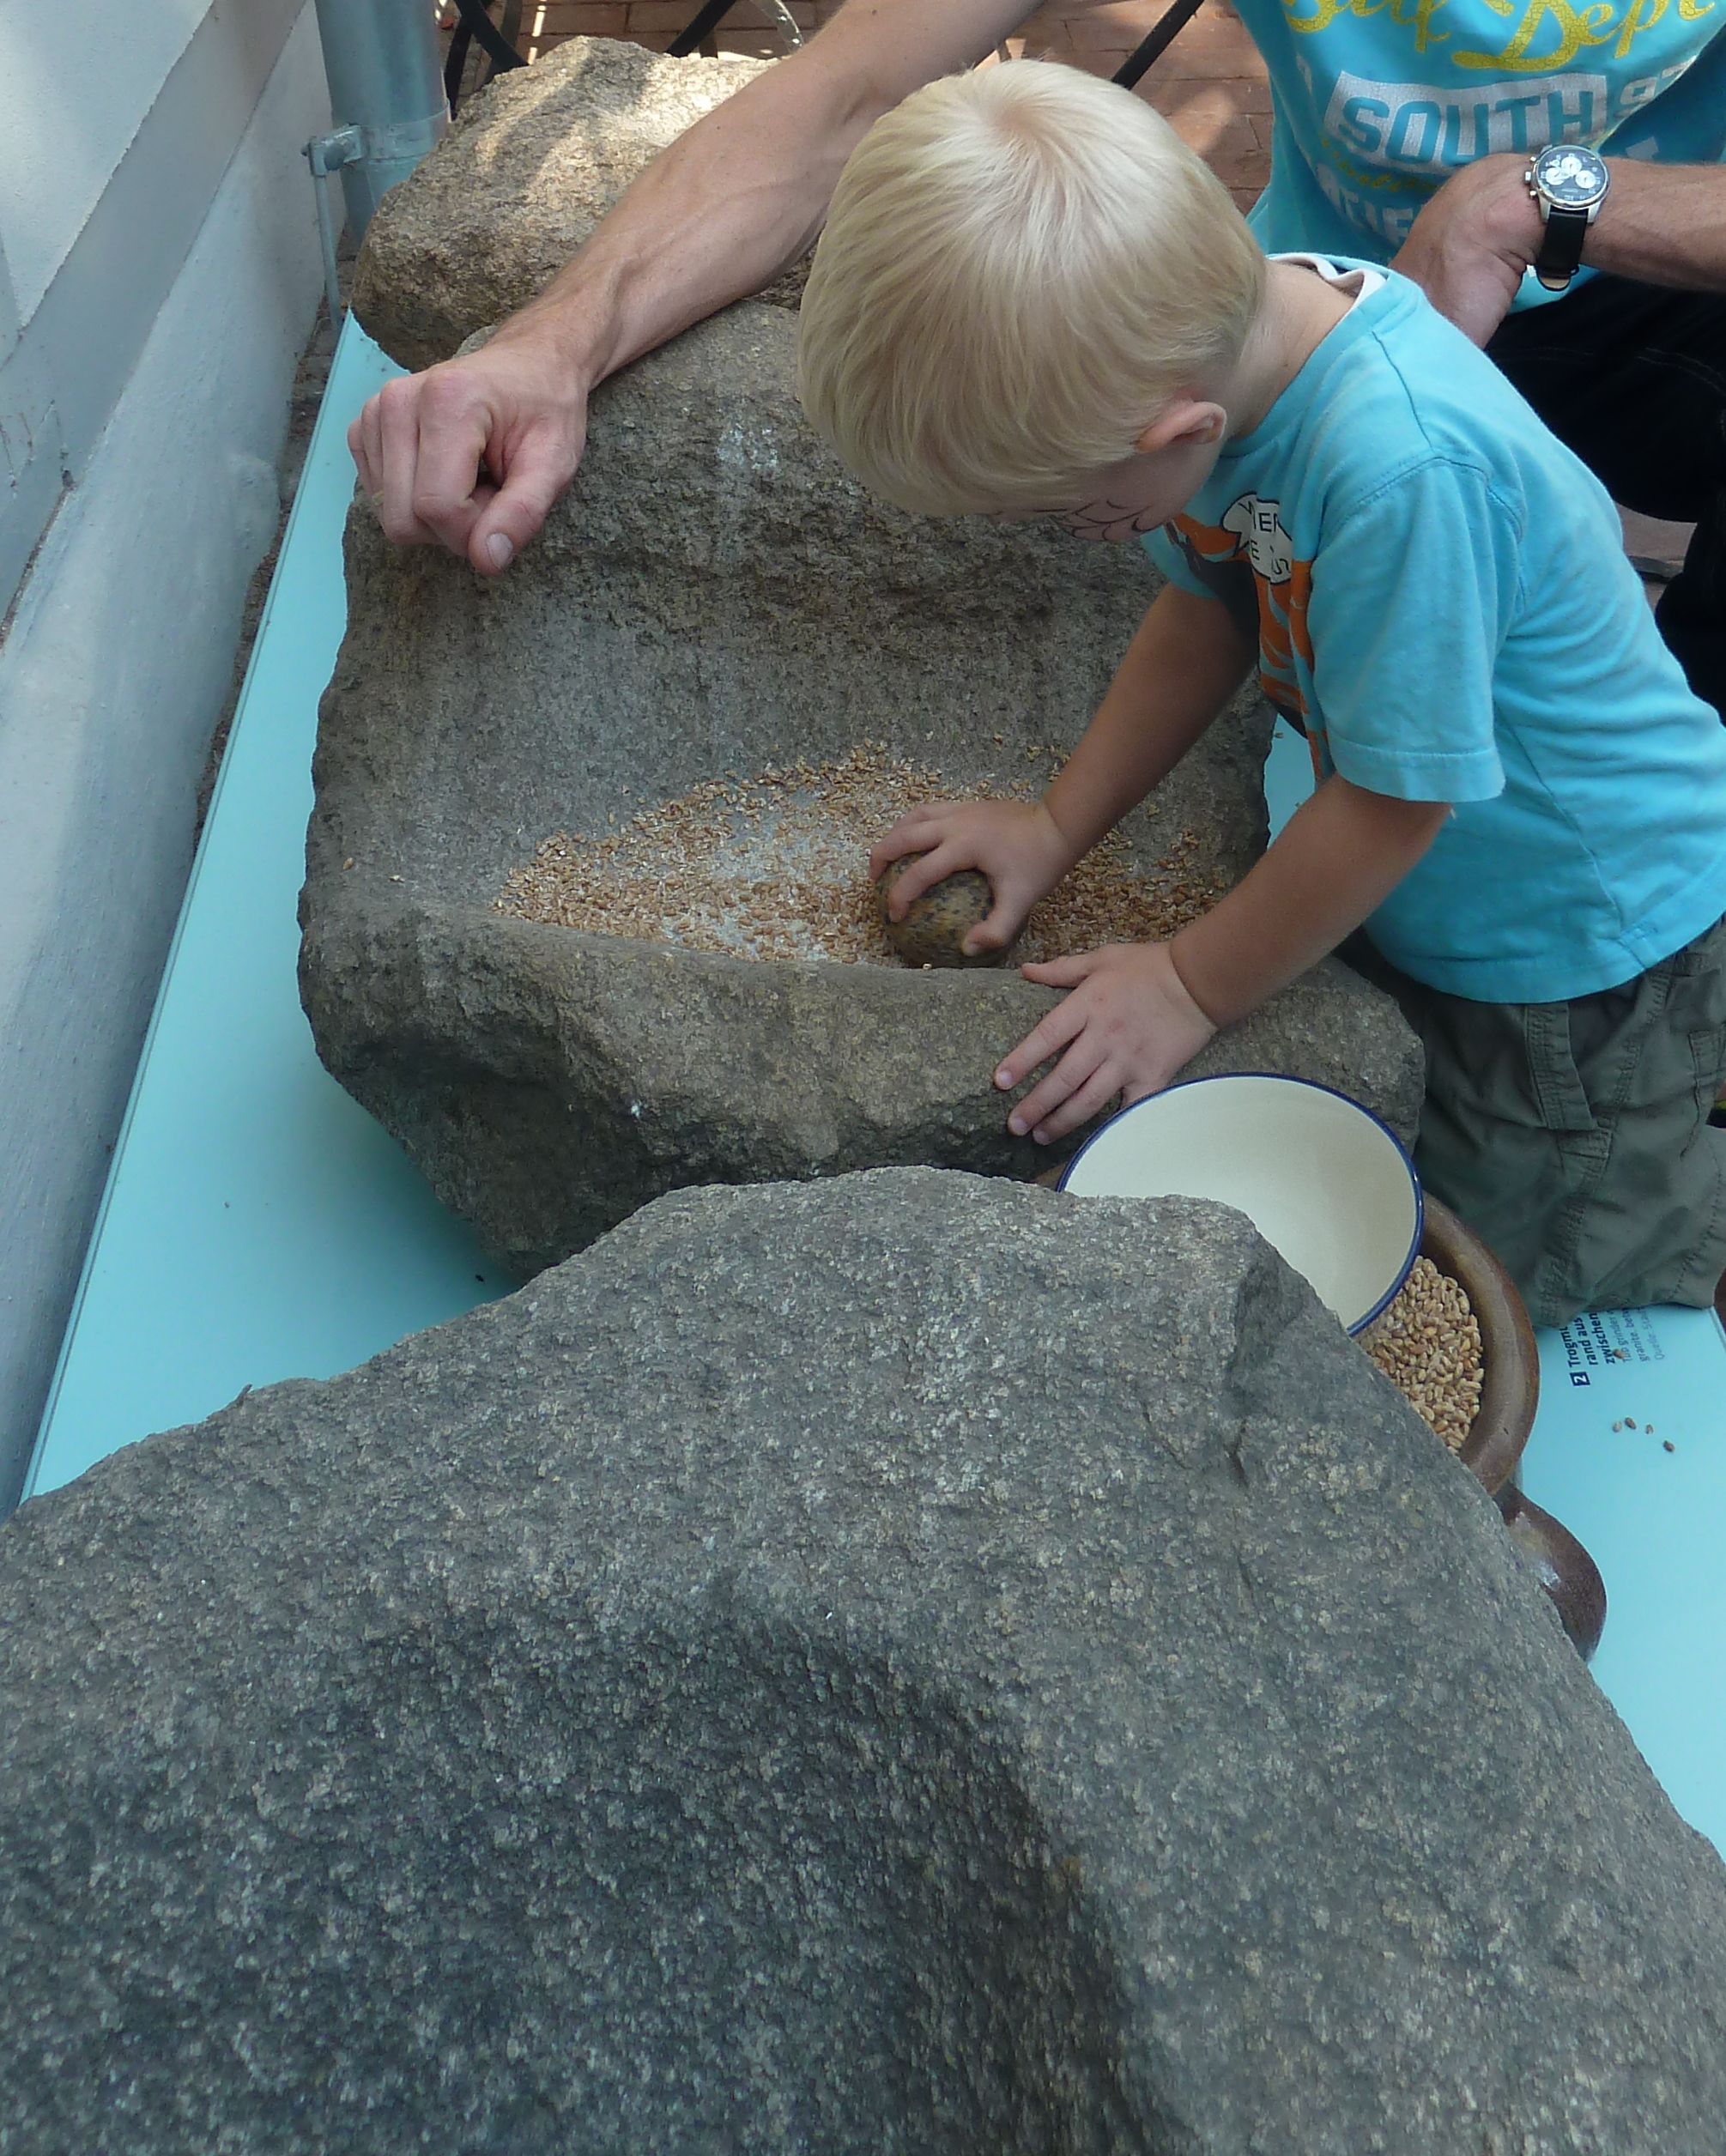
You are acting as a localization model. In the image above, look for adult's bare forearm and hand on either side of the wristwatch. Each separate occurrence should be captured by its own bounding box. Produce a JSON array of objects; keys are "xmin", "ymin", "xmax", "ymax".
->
[{"xmin": 1392, "ymin": 155, "xmax": 1726, "ymax": 345}]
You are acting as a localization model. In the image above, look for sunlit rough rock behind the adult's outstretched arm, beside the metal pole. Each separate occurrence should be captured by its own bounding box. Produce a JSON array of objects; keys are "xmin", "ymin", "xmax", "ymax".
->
[{"xmin": 354, "ymin": 37, "xmax": 806, "ymax": 366}]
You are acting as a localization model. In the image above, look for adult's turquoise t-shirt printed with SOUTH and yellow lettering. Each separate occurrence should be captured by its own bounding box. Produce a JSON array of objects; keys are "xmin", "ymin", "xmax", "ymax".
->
[{"xmin": 1237, "ymin": 0, "xmax": 1726, "ymax": 304}]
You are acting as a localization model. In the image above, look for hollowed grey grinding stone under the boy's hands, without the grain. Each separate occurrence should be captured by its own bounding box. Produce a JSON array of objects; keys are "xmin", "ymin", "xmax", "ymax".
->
[{"xmin": 301, "ymin": 306, "xmax": 1422, "ymax": 1275}]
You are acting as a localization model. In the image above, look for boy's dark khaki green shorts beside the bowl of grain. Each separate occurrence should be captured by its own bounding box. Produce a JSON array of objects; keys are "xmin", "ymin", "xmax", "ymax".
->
[{"xmin": 1341, "ymin": 921, "xmax": 1726, "ymax": 1326}]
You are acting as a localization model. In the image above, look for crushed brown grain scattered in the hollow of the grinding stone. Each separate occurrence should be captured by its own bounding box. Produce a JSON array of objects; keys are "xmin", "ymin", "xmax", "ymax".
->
[{"xmin": 495, "ymin": 742, "xmax": 1222, "ymax": 966}]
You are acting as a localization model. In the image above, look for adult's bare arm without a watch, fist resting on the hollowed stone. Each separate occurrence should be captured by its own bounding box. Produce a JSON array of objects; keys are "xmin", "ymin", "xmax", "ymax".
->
[{"xmin": 349, "ymin": 0, "xmax": 1033, "ymax": 573}]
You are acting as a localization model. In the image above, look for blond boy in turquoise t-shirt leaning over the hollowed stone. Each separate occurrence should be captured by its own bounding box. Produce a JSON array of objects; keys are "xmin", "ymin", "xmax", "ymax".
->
[{"xmin": 799, "ymin": 63, "xmax": 1726, "ymax": 1323}]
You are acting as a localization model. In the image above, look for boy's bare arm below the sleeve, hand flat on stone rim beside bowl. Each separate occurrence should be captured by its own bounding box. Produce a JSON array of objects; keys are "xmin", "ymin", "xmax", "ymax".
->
[{"xmin": 996, "ymin": 776, "xmax": 1450, "ymax": 1145}]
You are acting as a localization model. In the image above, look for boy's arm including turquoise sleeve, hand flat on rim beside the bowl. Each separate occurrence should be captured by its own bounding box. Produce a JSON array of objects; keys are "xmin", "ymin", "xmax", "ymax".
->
[{"xmin": 996, "ymin": 446, "xmax": 1517, "ymax": 1141}]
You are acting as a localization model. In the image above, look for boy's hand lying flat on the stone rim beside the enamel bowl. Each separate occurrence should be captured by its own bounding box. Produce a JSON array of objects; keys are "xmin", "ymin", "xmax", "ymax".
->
[{"xmin": 996, "ymin": 944, "xmax": 1217, "ymax": 1145}]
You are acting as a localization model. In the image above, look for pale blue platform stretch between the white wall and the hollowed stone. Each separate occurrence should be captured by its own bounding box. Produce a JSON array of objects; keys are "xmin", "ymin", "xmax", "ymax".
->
[{"xmin": 24, "ymin": 321, "xmax": 513, "ymax": 1499}]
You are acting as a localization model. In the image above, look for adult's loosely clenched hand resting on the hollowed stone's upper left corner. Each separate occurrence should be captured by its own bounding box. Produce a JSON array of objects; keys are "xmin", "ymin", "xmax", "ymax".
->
[{"xmin": 347, "ymin": 317, "xmax": 586, "ymax": 576}]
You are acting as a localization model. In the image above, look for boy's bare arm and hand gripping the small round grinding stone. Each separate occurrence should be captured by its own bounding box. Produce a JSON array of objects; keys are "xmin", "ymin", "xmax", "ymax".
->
[{"xmin": 869, "ymin": 584, "xmax": 1250, "ymax": 951}]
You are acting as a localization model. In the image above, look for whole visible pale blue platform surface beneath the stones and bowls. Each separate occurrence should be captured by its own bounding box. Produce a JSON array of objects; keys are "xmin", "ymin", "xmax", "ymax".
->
[{"xmin": 26, "ymin": 366, "xmax": 1726, "ymax": 1848}]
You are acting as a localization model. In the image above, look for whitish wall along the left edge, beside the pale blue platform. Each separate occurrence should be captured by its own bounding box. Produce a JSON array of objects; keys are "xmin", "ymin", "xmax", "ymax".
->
[{"xmin": 0, "ymin": 0, "xmax": 330, "ymax": 1505}]
